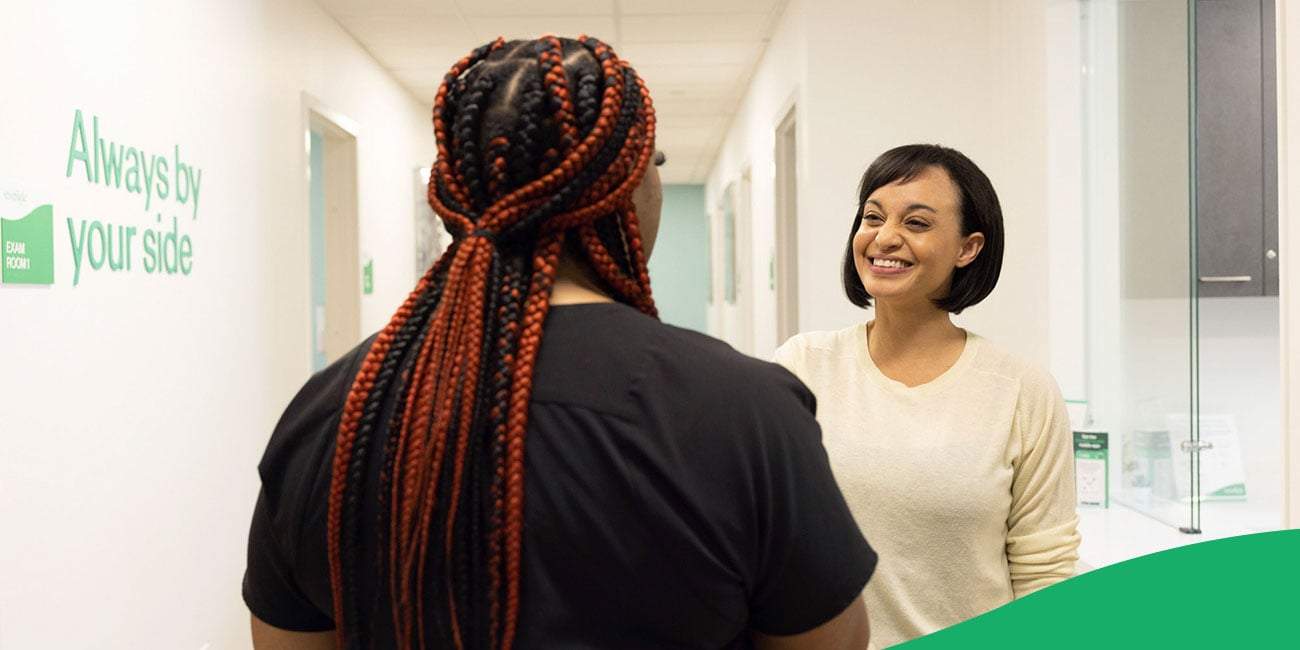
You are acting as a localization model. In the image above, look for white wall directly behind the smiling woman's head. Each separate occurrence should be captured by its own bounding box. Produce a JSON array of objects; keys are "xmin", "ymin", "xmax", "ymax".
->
[{"xmin": 707, "ymin": 0, "xmax": 1049, "ymax": 365}]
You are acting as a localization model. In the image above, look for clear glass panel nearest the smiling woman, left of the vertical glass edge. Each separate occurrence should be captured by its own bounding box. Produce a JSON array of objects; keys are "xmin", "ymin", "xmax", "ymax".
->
[{"xmin": 1080, "ymin": 0, "xmax": 1200, "ymax": 533}]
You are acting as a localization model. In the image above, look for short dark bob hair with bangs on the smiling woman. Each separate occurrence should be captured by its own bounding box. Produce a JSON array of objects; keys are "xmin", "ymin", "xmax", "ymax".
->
[{"xmin": 844, "ymin": 144, "xmax": 1005, "ymax": 313}]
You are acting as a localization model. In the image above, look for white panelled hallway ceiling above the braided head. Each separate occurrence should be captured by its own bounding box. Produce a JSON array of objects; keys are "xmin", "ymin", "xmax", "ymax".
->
[{"xmin": 316, "ymin": 0, "xmax": 787, "ymax": 183}]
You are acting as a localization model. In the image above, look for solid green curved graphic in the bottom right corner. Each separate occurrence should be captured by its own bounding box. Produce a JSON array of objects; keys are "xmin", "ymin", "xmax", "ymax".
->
[{"xmin": 896, "ymin": 530, "xmax": 1300, "ymax": 650}]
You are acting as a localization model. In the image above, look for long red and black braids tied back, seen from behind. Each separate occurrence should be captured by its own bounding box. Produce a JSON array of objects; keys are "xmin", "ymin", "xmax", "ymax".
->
[{"xmin": 326, "ymin": 36, "xmax": 657, "ymax": 649}]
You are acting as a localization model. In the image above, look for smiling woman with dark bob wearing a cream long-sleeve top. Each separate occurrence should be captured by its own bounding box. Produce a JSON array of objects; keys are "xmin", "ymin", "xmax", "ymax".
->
[{"xmin": 776, "ymin": 144, "xmax": 1079, "ymax": 647}]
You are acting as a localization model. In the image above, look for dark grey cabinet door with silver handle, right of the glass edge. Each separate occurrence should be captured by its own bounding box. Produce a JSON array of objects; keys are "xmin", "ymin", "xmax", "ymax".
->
[{"xmin": 1193, "ymin": 0, "xmax": 1278, "ymax": 296}]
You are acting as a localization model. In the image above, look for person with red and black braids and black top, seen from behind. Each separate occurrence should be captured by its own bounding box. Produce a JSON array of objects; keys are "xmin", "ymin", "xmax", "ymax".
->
[{"xmin": 243, "ymin": 36, "xmax": 876, "ymax": 649}]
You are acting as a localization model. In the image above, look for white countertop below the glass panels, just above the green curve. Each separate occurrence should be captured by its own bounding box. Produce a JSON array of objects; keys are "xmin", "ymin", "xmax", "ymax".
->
[{"xmin": 1078, "ymin": 502, "xmax": 1282, "ymax": 573}]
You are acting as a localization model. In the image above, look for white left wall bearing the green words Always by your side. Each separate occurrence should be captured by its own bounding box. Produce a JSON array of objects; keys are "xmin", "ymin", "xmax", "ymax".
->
[{"xmin": 0, "ymin": 0, "xmax": 431, "ymax": 650}]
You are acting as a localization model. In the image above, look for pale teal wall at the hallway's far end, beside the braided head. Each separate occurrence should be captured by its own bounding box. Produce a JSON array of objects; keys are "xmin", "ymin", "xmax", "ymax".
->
[{"xmin": 649, "ymin": 185, "xmax": 709, "ymax": 332}]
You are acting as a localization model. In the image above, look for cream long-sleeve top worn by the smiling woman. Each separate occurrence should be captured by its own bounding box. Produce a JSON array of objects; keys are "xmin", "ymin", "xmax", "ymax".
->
[{"xmin": 776, "ymin": 324, "xmax": 1079, "ymax": 647}]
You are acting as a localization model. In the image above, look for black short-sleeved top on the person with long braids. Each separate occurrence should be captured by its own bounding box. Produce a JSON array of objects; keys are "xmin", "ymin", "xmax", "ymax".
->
[{"xmin": 243, "ymin": 303, "xmax": 876, "ymax": 649}]
